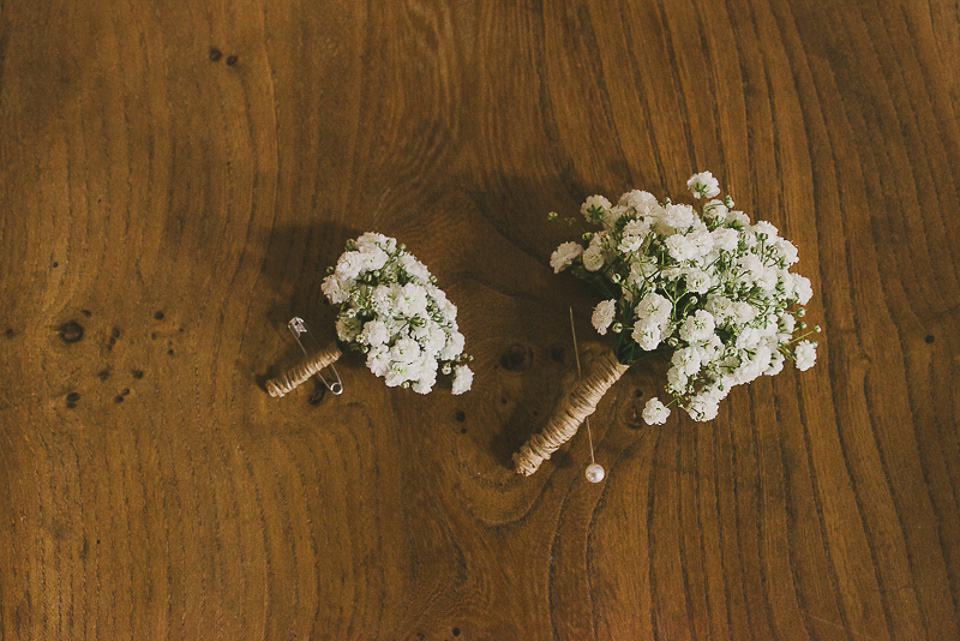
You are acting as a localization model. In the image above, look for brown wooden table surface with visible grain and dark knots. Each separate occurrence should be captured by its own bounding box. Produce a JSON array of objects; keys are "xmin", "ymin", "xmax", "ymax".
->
[{"xmin": 0, "ymin": 0, "xmax": 960, "ymax": 641}]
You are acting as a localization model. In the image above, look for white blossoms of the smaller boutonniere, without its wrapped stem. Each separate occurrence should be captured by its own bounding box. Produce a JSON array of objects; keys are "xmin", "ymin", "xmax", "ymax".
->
[{"xmin": 322, "ymin": 232, "xmax": 473, "ymax": 394}]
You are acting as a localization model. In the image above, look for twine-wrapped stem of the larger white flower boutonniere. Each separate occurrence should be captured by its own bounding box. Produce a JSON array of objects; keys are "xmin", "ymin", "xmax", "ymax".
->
[{"xmin": 513, "ymin": 352, "xmax": 629, "ymax": 476}]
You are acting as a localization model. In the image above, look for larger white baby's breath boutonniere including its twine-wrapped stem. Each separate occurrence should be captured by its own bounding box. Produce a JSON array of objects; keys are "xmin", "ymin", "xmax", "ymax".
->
[{"xmin": 513, "ymin": 172, "xmax": 820, "ymax": 475}]
